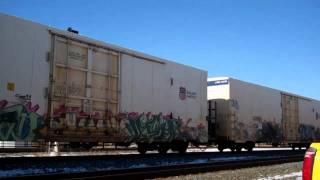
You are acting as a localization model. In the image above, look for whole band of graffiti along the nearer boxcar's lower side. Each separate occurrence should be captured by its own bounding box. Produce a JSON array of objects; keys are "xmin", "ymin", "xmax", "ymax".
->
[{"xmin": 0, "ymin": 100, "xmax": 207, "ymax": 142}]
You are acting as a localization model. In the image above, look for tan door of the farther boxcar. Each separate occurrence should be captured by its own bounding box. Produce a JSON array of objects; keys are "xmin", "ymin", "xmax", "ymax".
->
[{"xmin": 281, "ymin": 94, "xmax": 299, "ymax": 143}]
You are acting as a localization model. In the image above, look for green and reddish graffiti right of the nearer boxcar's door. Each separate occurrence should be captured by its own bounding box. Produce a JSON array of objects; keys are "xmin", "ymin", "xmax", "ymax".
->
[{"xmin": 119, "ymin": 112, "xmax": 206, "ymax": 142}]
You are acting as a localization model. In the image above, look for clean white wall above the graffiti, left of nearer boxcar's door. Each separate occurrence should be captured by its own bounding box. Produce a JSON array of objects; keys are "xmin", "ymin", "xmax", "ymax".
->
[{"xmin": 0, "ymin": 14, "xmax": 51, "ymax": 114}]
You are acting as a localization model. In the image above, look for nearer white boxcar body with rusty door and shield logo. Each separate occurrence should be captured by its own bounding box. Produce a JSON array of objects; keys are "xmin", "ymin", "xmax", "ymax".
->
[{"xmin": 0, "ymin": 14, "xmax": 207, "ymax": 153}]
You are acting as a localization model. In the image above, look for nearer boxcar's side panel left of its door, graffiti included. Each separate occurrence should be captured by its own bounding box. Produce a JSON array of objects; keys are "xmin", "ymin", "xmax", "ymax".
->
[{"xmin": 0, "ymin": 14, "xmax": 51, "ymax": 141}]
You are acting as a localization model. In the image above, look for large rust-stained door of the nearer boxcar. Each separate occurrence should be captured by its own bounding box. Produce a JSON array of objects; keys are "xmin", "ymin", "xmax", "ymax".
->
[{"xmin": 49, "ymin": 35, "xmax": 120, "ymax": 141}]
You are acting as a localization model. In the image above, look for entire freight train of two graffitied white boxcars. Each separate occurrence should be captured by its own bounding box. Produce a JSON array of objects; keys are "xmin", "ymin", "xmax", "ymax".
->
[{"xmin": 0, "ymin": 14, "xmax": 320, "ymax": 153}]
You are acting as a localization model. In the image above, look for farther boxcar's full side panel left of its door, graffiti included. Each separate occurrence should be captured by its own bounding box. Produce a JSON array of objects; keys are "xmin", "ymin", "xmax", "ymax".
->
[{"xmin": 230, "ymin": 79, "xmax": 282, "ymax": 142}]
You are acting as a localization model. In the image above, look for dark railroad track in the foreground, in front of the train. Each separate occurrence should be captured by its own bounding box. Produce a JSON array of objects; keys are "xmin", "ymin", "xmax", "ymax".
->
[{"xmin": 0, "ymin": 151, "xmax": 304, "ymax": 179}]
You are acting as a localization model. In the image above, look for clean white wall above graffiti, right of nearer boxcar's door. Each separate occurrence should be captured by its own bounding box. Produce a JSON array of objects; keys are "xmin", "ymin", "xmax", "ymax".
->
[{"xmin": 121, "ymin": 55, "xmax": 207, "ymax": 125}]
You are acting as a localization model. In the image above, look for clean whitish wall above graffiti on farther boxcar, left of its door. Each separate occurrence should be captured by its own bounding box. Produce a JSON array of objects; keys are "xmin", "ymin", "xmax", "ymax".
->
[{"xmin": 229, "ymin": 78, "xmax": 282, "ymax": 142}]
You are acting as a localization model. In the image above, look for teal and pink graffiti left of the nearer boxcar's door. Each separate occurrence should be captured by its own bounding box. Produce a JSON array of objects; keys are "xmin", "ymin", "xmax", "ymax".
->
[{"xmin": 0, "ymin": 100, "xmax": 43, "ymax": 141}]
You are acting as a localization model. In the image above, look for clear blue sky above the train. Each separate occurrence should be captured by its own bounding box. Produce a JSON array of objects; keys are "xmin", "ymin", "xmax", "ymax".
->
[{"xmin": 0, "ymin": 0, "xmax": 320, "ymax": 99}]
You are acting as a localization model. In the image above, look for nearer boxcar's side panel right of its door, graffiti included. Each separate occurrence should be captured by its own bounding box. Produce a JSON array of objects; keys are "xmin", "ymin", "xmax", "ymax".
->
[{"xmin": 121, "ymin": 55, "xmax": 207, "ymax": 142}]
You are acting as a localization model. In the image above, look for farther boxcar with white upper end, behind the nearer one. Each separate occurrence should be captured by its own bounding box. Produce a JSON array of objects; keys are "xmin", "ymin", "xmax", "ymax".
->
[{"xmin": 208, "ymin": 77, "xmax": 320, "ymax": 151}]
